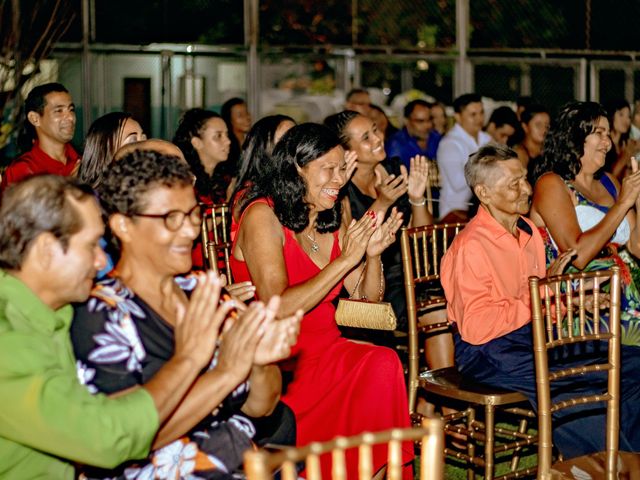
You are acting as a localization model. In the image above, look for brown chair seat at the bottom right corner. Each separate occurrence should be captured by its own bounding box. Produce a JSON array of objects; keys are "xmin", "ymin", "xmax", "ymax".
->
[{"xmin": 551, "ymin": 452, "xmax": 640, "ymax": 480}]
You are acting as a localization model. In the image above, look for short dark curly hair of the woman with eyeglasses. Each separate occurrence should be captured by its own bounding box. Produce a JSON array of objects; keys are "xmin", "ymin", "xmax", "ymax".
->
[{"xmin": 98, "ymin": 150, "xmax": 193, "ymax": 216}]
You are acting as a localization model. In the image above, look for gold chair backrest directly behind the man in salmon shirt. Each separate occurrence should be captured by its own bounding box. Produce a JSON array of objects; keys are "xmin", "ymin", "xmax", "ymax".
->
[{"xmin": 400, "ymin": 223, "xmax": 466, "ymax": 413}]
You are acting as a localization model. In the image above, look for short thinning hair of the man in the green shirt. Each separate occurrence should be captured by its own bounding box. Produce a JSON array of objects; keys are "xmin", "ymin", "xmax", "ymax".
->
[{"xmin": 0, "ymin": 175, "xmax": 95, "ymax": 270}]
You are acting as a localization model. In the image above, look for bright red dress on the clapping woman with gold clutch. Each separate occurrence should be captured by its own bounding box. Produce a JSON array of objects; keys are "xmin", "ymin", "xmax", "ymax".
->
[{"xmin": 231, "ymin": 199, "xmax": 413, "ymax": 479}]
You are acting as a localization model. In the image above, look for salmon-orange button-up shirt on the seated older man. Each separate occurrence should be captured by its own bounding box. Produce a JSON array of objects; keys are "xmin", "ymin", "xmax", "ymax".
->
[{"xmin": 440, "ymin": 207, "xmax": 546, "ymax": 345}]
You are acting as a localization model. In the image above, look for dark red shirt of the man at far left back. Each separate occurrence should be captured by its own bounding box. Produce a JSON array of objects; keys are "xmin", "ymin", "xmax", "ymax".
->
[{"xmin": 1, "ymin": 142, "xmax": 80, "ymax": 190}]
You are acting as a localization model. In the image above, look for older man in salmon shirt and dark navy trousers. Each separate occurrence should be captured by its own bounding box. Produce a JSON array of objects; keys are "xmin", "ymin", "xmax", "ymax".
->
[{"xmin": 440, "ymin": 144, "xmax": 640, "ymax": 458}]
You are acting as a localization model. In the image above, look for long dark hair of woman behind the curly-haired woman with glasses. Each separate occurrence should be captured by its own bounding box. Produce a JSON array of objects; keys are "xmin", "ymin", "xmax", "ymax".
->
[{"xmin": 78, "ymin": 112, "xmax": 133, "ymax": 188}]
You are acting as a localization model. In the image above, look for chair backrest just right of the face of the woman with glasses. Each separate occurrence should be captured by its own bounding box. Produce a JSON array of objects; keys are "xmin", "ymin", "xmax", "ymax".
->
[{"xmin": 200, "ymin": 203, "xmax": 232, "ymax": 283}]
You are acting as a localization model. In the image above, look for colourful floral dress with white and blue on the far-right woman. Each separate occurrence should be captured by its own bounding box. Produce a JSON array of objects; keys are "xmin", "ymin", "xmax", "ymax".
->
[{"xmin": 540, "ymin": 175, "xmax": 640, "ymax": 346}]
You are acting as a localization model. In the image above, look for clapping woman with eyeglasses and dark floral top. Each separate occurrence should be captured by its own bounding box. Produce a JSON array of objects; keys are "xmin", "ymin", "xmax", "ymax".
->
[{"xmin": 71, "ymin": 151, "xmax": 300, "ymax": 479}]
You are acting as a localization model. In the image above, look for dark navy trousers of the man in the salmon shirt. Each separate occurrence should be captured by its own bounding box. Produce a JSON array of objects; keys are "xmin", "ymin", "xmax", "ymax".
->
[{"xmin": 454, "ymin": 324, "xmax": 640, "ymax": 458}]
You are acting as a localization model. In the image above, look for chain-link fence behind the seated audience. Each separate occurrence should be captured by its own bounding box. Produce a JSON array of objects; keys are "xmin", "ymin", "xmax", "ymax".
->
[{"xmin": 15, "ymin": 0, "xmax": 640, "ymax": 152}]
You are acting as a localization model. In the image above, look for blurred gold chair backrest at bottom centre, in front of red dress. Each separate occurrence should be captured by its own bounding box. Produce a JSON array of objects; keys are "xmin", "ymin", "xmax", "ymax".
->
[{"xmin": 244, "ymin": 418, "xmax": 444, "ymax": 480}]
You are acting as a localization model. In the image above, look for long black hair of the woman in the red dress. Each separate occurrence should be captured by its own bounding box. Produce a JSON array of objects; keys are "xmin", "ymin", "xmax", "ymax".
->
[{"xmin": 245, "ymin": 123, "xmax": 342, "ymax": 233}]
